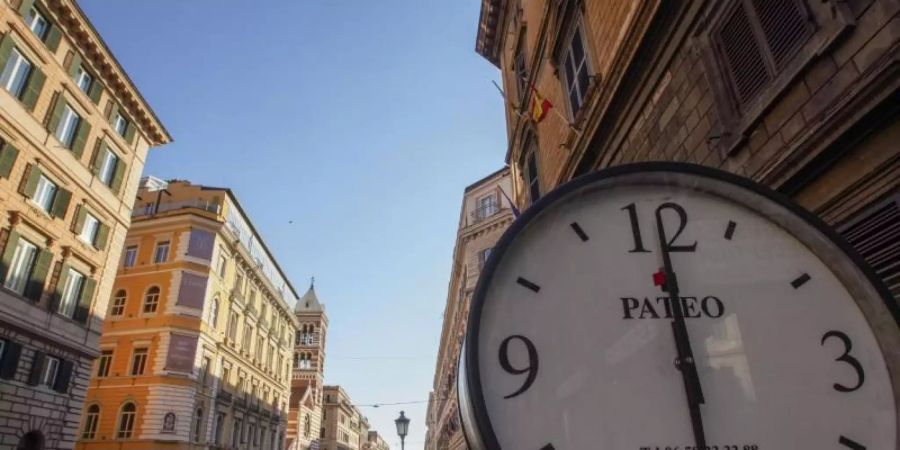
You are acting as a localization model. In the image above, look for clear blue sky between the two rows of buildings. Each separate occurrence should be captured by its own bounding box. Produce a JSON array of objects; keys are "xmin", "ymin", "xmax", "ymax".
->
[{"xmin": 81, "ymin": 0, "xmax": 506, "ymax": 448}]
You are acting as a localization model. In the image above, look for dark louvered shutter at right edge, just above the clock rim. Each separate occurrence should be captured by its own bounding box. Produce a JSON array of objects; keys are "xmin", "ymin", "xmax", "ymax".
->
[{"xmin": 842, "ymin": 197, "xmax": 900, "ymax": 299}]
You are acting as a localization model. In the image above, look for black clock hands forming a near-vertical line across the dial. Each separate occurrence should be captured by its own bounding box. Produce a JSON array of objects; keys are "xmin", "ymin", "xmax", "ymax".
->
[{"xmin": 656, "ymin": 204, "xmax": 706, "ymax": 449}]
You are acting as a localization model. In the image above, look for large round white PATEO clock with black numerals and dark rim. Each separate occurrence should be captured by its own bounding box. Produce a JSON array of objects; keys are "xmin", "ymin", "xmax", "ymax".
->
[{"xmin": 459, "ymin": 163, "xmax": 900, "ymax": 450}]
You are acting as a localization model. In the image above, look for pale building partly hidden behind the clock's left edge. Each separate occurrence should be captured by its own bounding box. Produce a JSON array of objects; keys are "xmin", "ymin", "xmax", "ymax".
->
[{"xmin": 425, "ymin": 168, "xmax": 515, "ymax": 450}]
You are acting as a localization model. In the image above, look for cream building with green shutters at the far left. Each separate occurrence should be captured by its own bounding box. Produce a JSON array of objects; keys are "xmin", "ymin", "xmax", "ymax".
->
[{"xmin": 0, "ymin": 0, "xmax": 171, "ymax": 450}]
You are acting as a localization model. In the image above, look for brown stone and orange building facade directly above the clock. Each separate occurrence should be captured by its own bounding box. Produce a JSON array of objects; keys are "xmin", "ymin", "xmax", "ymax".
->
[{"xmin": 476, "ymin": 0, "xmax": 900, "ymax": 296}]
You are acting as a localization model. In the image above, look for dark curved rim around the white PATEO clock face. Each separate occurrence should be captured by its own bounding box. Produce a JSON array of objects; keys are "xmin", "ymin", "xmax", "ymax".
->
[{"xmin": 457, "ymin": 161, "xmax": 900, "ymax": 450}]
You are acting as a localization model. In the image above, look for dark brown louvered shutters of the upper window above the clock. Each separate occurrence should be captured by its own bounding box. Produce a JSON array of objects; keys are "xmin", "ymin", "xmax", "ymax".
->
[{"xmin": 717, "ymin": 3, "xmax": 772, "ymax": 105}]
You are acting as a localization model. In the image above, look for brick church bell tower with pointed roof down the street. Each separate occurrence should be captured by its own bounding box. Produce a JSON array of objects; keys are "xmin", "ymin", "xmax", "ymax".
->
[{"xmin": 287, "ymin": 282, "xmax": 328, "ymax": 450}]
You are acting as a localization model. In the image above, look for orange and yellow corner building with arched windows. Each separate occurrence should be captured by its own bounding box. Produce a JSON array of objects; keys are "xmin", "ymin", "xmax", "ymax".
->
[{"xmin": 76, "ymin": 178, "xmax": 297, "ymax": 450}]
